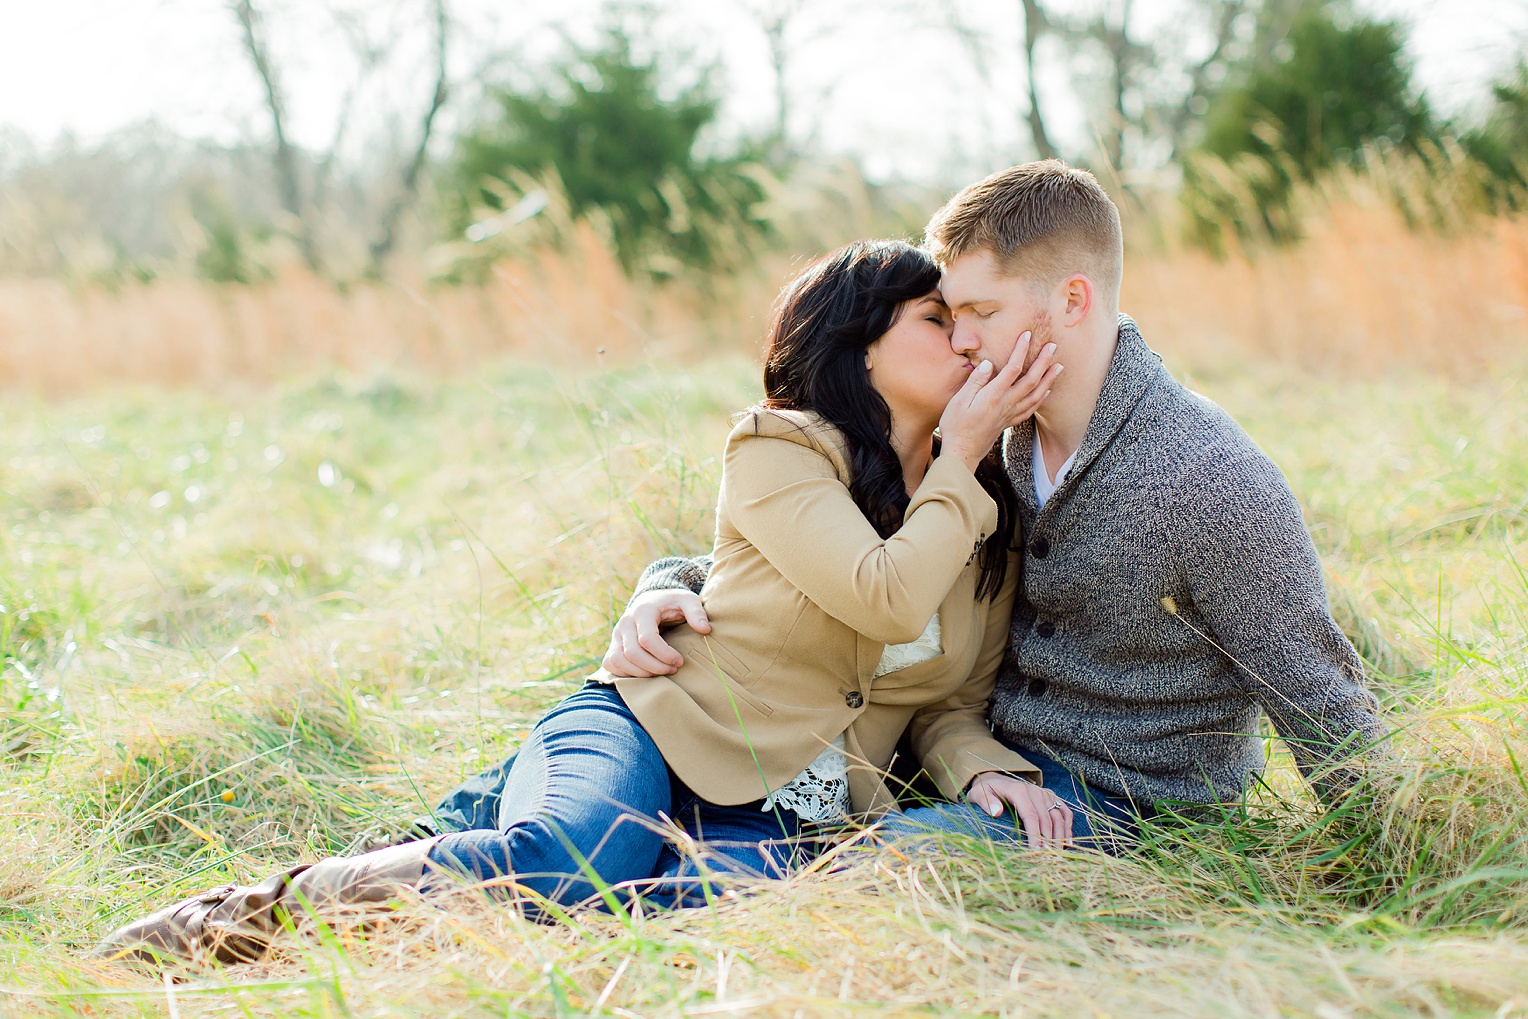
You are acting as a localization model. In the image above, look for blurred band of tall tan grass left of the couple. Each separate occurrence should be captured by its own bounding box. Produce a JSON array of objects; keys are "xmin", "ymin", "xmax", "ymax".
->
[{"xmin": 0, "ymin": 228, "xmax": 779, "ymax": 396}]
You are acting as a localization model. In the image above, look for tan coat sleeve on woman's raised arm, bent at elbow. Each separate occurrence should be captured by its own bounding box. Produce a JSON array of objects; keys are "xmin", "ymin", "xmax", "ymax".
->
[{"xmin": 718, "ymin": 428, "xmax": 998, "ymax": 643}]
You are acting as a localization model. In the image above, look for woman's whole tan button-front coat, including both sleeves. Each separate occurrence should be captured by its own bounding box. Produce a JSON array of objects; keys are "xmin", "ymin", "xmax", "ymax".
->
[{"xmin": 608, "ymin": 408, "xmax": 1039, "ymax": 816}]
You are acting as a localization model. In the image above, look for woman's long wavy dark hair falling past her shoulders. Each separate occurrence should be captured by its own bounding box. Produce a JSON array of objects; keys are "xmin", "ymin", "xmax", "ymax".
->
[{"xmin": 764, "ymin": 241, "xmax": 1018, "ymax": 599}]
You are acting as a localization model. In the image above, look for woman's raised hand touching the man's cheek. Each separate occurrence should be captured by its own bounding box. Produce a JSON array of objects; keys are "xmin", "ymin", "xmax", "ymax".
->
[{"xmin": 940, "ymin": 333, "xmax": 1062, "ymax": 471}]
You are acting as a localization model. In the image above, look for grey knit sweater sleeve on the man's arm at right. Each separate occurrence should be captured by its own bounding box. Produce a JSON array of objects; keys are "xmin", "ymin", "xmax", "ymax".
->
[{"xmin": 1164, "ymin": 452, "xmax": 1386, "ymax": 794}]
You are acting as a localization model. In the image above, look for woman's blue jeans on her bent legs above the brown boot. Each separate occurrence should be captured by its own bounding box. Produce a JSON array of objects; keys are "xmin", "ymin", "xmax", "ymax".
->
[{"xmin": 426, "ymin": 683, "xmax": 801, "ymax": 917}]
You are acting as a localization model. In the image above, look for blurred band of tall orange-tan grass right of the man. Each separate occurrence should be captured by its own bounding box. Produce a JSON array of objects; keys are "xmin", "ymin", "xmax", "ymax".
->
[{"xmin": 1122, "ymin": 202, "xmax": 1528, "ymax": 374}]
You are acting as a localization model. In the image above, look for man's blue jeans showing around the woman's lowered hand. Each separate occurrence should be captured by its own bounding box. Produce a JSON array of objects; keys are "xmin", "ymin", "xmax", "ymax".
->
[{"xmin": 882, "ymin": 750, "xmax": 1152, "ymax": 854}]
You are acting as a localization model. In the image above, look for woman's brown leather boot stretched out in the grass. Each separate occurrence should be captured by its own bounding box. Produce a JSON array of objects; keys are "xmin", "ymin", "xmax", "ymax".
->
[{"xmin": 92, "ymin": 836, "xmax": 440, "ymax": 964}]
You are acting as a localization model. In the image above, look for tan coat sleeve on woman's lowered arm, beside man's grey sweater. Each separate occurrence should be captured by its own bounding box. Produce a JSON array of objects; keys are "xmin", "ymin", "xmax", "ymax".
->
[{"xmin": 908, "ymin": 553, "xmax": 1041, "ymax": 799}]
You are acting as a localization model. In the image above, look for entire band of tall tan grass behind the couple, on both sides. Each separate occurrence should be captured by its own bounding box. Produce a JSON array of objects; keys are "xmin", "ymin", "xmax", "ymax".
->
[{"xmin": 0, "ymin": 199, "xmax": 1528, "ymax": 396}]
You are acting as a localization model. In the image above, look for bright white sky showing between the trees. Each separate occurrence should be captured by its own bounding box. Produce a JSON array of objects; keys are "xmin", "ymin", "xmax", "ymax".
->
[{"xmin": 0, "ymin": 0, "xmax": 1528, "ymax": 179}]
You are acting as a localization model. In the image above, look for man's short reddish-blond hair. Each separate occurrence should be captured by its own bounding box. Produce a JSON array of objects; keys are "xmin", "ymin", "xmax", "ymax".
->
[{"xmin": 924, "ymin": 159, "xmax": 1125, "ymax": 306}]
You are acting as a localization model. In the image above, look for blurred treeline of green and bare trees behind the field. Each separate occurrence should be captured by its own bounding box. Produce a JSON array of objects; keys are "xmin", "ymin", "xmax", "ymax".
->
[{"xmin": 0, "ymin": 0, "xmax": 1528, "ymax": 283}]
